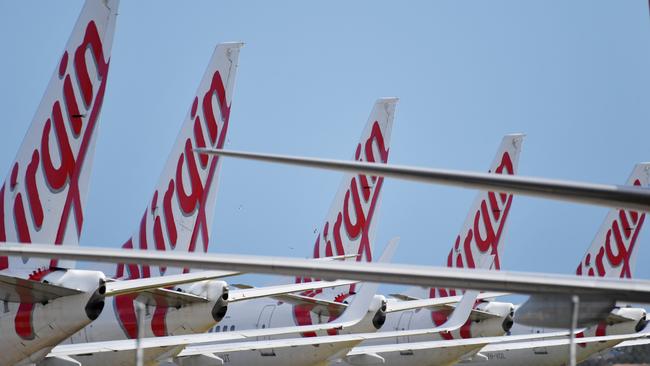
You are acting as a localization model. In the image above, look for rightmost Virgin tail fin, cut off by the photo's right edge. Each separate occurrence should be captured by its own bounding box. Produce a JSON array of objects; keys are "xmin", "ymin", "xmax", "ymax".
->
[{"xmin": 576, "ymin": 163, "xmax": 650, "ymax": 278}]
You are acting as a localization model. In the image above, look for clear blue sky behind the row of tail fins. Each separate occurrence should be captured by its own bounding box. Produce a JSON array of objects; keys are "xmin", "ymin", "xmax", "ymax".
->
[{"xmin": 0, "ymin": 0, "xmax": 650, "ymax": 298}]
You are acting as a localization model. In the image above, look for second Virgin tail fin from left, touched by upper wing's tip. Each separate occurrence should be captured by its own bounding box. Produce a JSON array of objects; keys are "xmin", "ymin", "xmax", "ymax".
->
[{"xmin": 116, "ymin": 42, "xmax": 243, "ymax": 278}]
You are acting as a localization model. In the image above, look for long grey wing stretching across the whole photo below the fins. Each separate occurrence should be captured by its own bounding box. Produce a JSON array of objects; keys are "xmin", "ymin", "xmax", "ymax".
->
[{"xmin": 5, "ymin": 243, "xmax": 650, "ymax": 303}]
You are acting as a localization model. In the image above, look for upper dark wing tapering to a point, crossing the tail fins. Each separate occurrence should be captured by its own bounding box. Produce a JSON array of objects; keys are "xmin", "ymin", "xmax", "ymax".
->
[{"xmin": 194, "ymin": 148, "xmax": 650, "ymax": 211}]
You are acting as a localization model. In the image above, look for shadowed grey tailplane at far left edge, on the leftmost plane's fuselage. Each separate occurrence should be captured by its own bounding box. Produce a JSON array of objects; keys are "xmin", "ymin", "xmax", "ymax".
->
[{"xmin": 0, "ymin": 275, "xmax": 82, "ymax": 303}]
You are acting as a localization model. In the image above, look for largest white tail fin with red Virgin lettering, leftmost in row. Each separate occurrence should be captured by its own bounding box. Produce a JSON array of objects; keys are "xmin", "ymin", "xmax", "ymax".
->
[{"xmin": 0, "ymin": 0, "xmax": 119, "ymax": 272}]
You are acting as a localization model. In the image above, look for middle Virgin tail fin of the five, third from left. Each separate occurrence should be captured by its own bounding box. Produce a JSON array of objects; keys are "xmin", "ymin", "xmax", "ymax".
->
[{"xmin": 314, "ymin": 98, "xmax": 398, "ymax": 262}]
